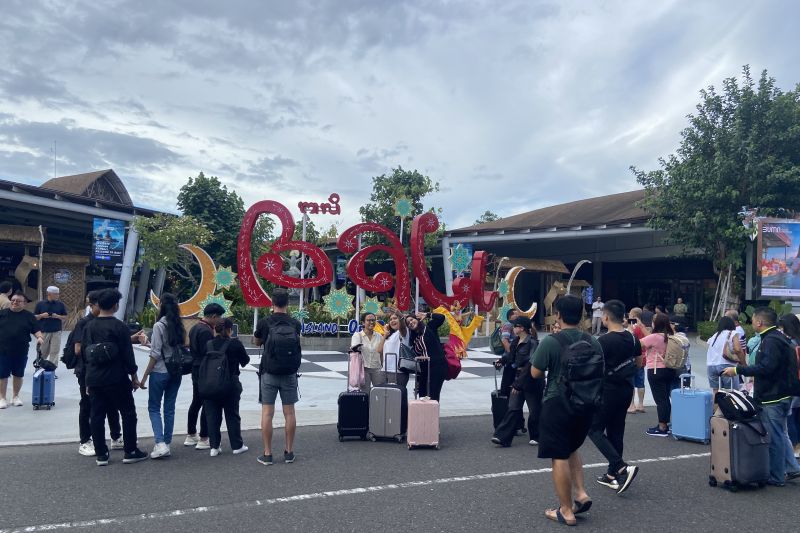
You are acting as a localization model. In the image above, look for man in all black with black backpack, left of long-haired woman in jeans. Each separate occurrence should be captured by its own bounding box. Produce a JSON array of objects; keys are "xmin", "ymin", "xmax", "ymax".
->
[{"xmin": 81, "ymin": 289, "xmax": 148, "ymax": 466}]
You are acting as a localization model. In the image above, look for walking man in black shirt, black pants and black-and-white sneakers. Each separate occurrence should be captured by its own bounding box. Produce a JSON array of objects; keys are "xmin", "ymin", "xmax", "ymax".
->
[{"xmin": 589, "ymin": 300, "xmax": 642, "ymax": 494}]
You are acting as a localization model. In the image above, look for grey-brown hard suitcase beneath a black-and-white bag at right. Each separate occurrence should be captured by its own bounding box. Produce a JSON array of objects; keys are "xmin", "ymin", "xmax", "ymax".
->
[{"xmin": 708, "ymin": 416, "xmax": 770, "ymax": 492}]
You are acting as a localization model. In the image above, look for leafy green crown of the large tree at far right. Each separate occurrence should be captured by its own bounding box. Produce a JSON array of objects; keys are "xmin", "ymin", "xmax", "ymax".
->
[{"xmin": 631, "ymin": 66, "xmax": 800, "ymax": 280}]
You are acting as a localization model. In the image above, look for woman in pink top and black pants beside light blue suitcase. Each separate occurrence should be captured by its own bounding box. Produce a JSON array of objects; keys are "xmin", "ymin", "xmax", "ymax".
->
[{"xmin": 641, "ymin": 313, "xmax": 676, "ymax": 437}]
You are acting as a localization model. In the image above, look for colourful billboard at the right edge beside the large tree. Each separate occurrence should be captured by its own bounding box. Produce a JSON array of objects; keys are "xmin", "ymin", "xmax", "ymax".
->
[{"xmin": 756, "ymin": 218, "xmax": 800, "ymax": 300}]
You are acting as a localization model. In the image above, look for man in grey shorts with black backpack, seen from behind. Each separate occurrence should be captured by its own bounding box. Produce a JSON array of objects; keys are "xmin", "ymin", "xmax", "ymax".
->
[{"xmin": 253, "ymin": 289, "xmax": 302, "ymax": 466}]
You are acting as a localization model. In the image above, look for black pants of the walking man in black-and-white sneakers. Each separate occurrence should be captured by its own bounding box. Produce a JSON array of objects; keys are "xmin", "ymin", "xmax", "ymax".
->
[{"xmin": 589, "ymin": 385, "xmax": 633, "ymax": 477}]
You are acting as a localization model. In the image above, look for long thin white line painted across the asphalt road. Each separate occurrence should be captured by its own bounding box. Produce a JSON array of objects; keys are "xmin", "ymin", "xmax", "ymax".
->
[{"xmin": 0, "ymin": 452, "xmax": 711, "ymax": 533}]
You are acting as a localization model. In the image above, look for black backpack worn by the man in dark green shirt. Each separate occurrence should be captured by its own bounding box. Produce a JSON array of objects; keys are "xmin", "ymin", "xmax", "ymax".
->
[{"xmin": 555, "ymin": 333, "xmax": 605, "ymax": 416}]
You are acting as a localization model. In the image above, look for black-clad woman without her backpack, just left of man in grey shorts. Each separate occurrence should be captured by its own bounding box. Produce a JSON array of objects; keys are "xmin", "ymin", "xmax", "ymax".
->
[{"xmin": 201, "ymin": 318, "xmax": 250, "ymax": 457}]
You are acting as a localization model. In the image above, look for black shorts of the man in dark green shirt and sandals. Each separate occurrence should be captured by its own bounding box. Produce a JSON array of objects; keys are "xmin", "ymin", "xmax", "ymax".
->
[{"xmin": 539, "ymin": 396, "xmax": 594, "ymax": 459}]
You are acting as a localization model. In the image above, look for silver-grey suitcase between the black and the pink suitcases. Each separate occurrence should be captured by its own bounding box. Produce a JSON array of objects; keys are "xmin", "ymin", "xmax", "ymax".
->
[{"xmin": 367, "ymin": 354, "xmax": 408, "ymax": 442}]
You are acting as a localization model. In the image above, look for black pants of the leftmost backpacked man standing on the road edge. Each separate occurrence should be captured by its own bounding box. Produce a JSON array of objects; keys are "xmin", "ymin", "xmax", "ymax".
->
[{"xmin": 89, "ymin": 380, "xmax": 136, "ymax": 457}]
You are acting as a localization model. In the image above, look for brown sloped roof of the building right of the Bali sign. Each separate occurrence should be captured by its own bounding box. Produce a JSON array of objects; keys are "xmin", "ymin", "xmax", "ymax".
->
[{"xmin": 448, "ymin": 189, "xmax": 648, "ymax": 234}]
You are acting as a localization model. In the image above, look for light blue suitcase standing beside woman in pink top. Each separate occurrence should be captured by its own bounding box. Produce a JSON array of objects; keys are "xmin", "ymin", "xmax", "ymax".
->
[{"xmin": 670, "ymin": 374, "xmax": 714, "ymax": 444}]
